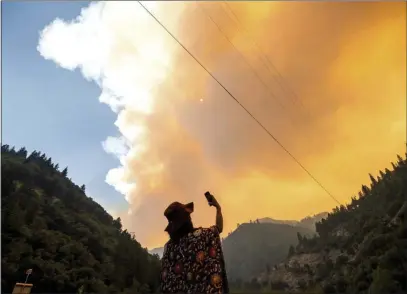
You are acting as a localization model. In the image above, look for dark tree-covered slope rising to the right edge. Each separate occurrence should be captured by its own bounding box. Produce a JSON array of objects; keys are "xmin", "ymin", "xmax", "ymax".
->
[{"xmin": 259, "ymin": 156, "xmax": 407, "ymax": 294}]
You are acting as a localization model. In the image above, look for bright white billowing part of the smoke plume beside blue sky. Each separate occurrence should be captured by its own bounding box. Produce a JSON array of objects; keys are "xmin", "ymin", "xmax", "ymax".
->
[{"xmin": 38, "ymin": 1, "xmax": 185, "ymax": 209}]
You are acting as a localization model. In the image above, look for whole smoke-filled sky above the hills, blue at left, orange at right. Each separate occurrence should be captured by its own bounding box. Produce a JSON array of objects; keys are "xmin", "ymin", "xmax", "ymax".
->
[{"xmin": 3, "ymin": 2, "xmax": 406, "ymax": 247}]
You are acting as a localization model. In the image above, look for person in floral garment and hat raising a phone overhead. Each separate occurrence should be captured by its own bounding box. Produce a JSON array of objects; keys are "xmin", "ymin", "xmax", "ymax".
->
[{"xmin": 161, "ymin": 192, "xmax": 228, "ymax": 293}]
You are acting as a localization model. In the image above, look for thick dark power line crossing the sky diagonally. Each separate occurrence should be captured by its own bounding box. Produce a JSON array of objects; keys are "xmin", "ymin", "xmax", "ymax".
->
[{"xmin": 137, "ymin": 1, "xmax": 341, "ymax": 205}]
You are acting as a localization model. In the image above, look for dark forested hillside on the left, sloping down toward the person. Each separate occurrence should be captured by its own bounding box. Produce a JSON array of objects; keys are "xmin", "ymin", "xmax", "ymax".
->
[{"xmin": 1, "ymin": 145, "xmax": 160, "ymax": 293}]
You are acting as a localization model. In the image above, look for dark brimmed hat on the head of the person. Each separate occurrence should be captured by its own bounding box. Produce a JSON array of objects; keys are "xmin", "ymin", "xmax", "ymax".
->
[{"xmin": 164, "ymin": 202, "xmax": 194, "ymax": 232}]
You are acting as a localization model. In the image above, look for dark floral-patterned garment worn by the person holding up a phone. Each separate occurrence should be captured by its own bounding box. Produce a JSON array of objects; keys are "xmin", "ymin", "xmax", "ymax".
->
[{"xmin": 161, "ymin": 226, "xmax": 228, "ymax": 293}]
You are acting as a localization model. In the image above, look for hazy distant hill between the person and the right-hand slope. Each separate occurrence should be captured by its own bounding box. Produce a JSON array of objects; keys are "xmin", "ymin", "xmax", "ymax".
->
[{"xmin": 223, "ymin": 223, "xmax": 313, "ymax": 283}]
